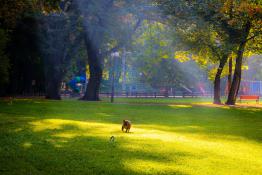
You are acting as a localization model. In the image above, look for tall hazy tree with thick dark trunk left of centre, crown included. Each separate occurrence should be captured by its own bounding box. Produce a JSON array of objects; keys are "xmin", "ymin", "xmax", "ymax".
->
[{"xmin": 71, "ymin": 0, "xmax": 151, "ymax": 101}]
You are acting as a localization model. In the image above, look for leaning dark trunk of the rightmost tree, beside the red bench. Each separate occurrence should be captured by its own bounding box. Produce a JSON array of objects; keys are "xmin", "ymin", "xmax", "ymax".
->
[{"xmin": 226, "ymin": 22, "xmax": 251, "ymax": 105}]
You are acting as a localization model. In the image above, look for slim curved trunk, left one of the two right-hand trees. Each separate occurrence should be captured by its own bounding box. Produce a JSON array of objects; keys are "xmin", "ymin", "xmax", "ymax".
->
[{"xmin": 213, "ymin": 56, "xmax": 227, "ymax": 104}]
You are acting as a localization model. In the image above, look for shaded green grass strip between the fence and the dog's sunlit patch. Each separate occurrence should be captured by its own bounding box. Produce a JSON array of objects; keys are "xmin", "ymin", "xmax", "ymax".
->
[{"xmin": 0, "ymin": 100, "xmax": 262, "ymax": 142}]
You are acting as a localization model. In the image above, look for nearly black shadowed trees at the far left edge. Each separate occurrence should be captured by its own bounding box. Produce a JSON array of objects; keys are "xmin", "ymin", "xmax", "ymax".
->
[{"xmin": 0, "ymin": 0, "xmax": 59, "ymax": 96}]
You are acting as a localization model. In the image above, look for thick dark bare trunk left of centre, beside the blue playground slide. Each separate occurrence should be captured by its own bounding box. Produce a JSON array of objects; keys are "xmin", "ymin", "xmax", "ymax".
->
[{"xmin": 82, "ymin": 35, "xmax": 103, "ymax": 101}]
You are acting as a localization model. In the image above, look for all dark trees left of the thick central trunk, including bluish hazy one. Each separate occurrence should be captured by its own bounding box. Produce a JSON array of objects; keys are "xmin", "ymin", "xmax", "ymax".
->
[{"xmin": 0, "ymin": 0, "xmax": 85, "ymax": 99}]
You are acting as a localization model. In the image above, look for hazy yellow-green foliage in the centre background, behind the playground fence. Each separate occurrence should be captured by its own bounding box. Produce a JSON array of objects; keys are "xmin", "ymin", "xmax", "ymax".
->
[{"xmin": 130, "ymin": 20, "xmax": 209, "ymax": 88}]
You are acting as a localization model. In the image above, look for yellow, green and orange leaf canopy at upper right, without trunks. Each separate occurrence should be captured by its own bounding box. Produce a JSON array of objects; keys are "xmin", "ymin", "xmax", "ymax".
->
[{"xmin": 156, "ymin": 0, "xmax": 262, "ymax": 87}]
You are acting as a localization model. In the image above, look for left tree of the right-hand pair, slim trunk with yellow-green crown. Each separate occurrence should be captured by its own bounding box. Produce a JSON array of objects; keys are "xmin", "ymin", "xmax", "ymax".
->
[{"xmin": 158, "ymin": 0, "xmax": 233, "ymax": 104}]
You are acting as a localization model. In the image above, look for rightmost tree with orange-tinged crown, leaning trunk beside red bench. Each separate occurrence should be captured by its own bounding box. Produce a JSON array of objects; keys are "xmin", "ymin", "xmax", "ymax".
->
[{"xmin": 222, "ymin": 0, "xmax": 262, "ymax": 105}]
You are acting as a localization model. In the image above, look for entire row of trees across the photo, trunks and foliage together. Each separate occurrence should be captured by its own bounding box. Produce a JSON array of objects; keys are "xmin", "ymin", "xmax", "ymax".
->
[{"xmin": 0, "ymin": 0, "xmax": 261, "ymax": 104}]
